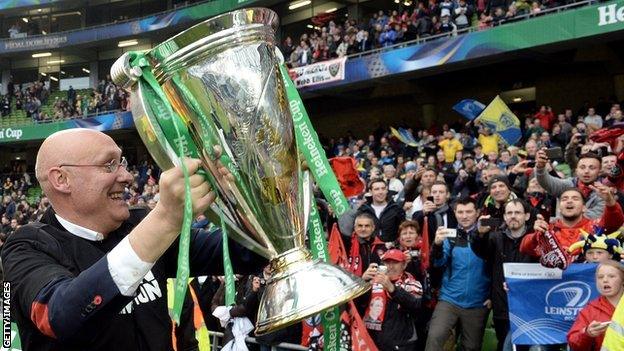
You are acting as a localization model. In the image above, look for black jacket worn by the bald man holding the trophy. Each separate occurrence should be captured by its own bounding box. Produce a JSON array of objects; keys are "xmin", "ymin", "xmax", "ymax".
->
[{"xmin": 2, "ymin": 209, "xmax": 263, "ymax": 351}]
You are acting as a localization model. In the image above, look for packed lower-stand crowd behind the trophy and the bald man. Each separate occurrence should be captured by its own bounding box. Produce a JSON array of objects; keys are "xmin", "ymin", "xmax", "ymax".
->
[{"xmin": 0, "ymin": 101, "xmax": 624, "ymax": 351}]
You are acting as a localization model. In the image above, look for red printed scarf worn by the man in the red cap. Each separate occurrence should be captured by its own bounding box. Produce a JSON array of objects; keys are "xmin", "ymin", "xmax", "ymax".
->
[{"xmin": 364, "ymin": 272, "xmax": 422, "ymax": 331}]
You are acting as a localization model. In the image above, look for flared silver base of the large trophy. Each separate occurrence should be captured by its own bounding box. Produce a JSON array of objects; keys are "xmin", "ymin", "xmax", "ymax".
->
[{"xmin": 256, "ymin": 248, "xmax": 370, "ymax": 335}]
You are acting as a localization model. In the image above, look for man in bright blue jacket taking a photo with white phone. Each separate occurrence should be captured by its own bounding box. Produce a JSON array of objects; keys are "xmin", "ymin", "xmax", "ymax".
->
[{"xmin": 425, "ymin": 198, "xmax": 491, "ymax": 351}]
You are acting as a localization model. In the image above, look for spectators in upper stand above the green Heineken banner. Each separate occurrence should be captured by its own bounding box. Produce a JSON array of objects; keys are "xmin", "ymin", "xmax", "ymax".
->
[{"xmin": 281, "ymin": 0, "xmax": 574, "ymax": 67}]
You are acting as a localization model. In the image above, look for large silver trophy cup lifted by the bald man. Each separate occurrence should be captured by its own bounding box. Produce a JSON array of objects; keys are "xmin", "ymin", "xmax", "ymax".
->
[{"xmin": 111, "ymin": 8, "xmax": 369, "ymax": 335}]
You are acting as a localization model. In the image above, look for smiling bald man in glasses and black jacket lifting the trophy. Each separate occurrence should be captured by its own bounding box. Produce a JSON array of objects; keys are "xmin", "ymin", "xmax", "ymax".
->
[{"xmin": 2, "ymin": 129, "xmax": 263, "ymax": 351}]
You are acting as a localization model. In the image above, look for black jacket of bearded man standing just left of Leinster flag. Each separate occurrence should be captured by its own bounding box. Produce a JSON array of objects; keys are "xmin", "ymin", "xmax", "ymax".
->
[{"xmin": 471, "ymin": 229, "xmax": 537, "ymax": 320}]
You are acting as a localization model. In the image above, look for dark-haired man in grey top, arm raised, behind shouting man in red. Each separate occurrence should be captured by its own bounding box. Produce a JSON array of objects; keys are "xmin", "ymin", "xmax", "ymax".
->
[{"xmin": 535, "ymin": 149, "xmax": 605, "ymax": 219}]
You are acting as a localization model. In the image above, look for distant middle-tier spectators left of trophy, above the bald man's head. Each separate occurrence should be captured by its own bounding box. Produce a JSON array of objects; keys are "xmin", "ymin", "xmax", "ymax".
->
[{"xmin": 0, "ymin": 75, "xmax": 129, "ymax": 122}]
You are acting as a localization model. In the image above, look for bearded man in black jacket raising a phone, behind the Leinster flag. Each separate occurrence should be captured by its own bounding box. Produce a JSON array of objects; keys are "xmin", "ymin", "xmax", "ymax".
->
[{"xmin": 471, "ymin": 199, "xmax": 537, "ymax": 351}]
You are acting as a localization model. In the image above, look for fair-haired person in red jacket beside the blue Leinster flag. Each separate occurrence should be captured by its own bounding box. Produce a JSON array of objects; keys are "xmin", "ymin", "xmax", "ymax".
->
[{"xmin": 568, "ymin": 260, "xmax": 624, "ymax": 351}]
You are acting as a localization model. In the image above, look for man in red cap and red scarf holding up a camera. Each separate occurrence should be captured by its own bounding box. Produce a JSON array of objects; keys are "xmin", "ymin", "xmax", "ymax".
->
[{"xmin": 363, "ymin": 249, "xmax": 422, "ymax": 351}]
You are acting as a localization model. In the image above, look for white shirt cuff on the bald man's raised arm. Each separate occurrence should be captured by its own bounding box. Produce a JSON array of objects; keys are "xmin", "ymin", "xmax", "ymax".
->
[{"xmin": 107, "ymin": 236, "xmax": 154, "ymax": 296}]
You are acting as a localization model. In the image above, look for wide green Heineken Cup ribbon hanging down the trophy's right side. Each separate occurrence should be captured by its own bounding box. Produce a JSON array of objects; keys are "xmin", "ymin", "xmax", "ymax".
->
[{"xmin": 280, "ymin": 65, "xmax": 349, "ymax": 351}]
